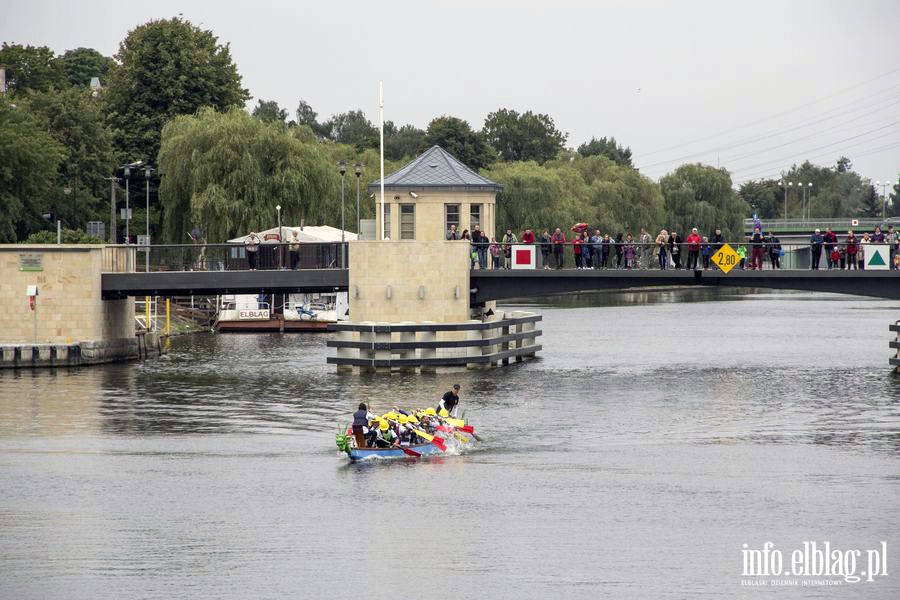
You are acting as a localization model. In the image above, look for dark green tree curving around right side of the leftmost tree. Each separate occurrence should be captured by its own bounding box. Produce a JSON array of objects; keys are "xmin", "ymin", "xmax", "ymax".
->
[{"xmin": 23, "ymin": 87, "xmax": 116, "ymax": 227}]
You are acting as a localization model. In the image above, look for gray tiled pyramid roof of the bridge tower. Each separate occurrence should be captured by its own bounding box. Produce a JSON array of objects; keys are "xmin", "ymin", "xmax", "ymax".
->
[{"xmin": 369, "ymin": 146, "xmax": 503, "ymax": 192}]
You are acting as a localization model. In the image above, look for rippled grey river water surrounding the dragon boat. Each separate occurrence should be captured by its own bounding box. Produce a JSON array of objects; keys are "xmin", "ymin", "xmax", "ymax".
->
[{"xmin": 0, "ymin": 290, "xmax": 900, "ymax": 599}]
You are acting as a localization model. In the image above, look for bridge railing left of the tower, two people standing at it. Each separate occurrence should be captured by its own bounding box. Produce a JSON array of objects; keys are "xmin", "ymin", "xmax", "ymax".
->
[{"xmin": 104, "ymin": 242, "xmax": 347, "ymax": 272}]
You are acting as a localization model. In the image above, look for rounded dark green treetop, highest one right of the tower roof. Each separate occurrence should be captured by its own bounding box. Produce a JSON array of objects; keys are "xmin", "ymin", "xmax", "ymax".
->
[{"xmin": 482, "ymin": 108, "xmax": 567, "ymax": 163}]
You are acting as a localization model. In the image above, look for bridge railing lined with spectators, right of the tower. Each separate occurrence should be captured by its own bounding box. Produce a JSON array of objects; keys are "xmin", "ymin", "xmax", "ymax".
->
[{"xmin": 471, "ymin": 240, "xmax": 900, "ymax": 270}]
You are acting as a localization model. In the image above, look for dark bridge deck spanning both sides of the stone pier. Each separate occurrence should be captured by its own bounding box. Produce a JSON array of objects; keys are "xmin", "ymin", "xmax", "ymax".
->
[{"xmin": 101, "ymin": 269, "xmax": 900, "ymax": 305}]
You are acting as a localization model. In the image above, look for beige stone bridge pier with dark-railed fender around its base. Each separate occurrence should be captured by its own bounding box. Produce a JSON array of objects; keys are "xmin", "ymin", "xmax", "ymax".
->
[{"xmin": 328, "ymin": 240, "xmax": 541, "ymax": 373}]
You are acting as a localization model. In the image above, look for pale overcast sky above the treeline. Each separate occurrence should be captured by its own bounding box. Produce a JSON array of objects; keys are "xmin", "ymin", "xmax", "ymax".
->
[{"xmin": 0, "ymin": 0, "xmax": 900, "ymax": 188}]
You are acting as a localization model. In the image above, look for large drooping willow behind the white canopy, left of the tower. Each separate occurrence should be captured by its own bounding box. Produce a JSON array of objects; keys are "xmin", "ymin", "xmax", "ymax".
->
[{"xmin": 159, "ymin": 108, "xmax": 340, "ymax": 242}]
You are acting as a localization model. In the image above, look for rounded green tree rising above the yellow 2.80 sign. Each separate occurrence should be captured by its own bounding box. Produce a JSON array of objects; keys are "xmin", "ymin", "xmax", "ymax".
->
[{"xmin": 659, "ymin": 164, "xmax": 749, "ymax": 240}]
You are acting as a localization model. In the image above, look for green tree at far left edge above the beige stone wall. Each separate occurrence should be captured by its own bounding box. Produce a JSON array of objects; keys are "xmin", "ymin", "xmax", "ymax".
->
[{"xmin": 0, "ymin": 97, "xmax": 65, "ymax": 243}]
